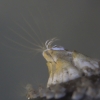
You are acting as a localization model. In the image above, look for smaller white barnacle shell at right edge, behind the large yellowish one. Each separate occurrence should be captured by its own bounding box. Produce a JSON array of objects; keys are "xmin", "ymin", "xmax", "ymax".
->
[{"xmin": 73, "ymin": 51, "xmax": 100, "ymax": 76}]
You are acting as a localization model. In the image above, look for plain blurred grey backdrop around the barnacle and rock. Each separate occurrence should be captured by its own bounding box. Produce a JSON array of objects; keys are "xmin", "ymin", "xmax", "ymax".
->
[{"xmin": 0, "ymin": 0, "xmax": 100, "ymax": 100}]
